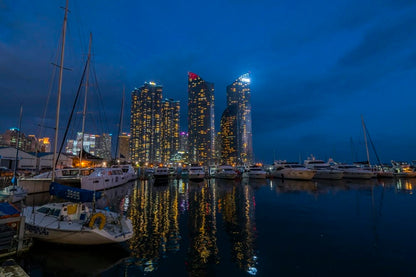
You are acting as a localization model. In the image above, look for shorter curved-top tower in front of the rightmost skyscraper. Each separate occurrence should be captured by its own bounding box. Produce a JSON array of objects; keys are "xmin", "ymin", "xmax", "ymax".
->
[{"xmin": 220, "ymin": 104, "xmax": 238, "ymax": 165}]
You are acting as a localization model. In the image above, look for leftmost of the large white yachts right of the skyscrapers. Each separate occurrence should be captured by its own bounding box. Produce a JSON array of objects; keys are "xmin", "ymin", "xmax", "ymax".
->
[{"xmin": 271, "ymin": 161, "xmax": 316, "ymax": 180}]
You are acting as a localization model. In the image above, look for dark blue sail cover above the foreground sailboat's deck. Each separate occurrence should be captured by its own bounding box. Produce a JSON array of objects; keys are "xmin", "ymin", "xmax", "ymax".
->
[{"xmin": 49, "ymin": 182, "xmax": 101, "ymax": 202}]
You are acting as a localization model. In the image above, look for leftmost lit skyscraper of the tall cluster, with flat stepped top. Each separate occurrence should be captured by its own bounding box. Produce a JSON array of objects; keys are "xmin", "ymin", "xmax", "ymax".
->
[{"xmin": 130, "ymin": 82, "xmax": 162, "ymax": 164}]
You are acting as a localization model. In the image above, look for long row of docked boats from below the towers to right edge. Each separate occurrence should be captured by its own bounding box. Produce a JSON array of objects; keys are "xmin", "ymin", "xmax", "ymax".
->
[{"xmin": 145, "ymin": 157, "xmax": 416, "ymax": 183}]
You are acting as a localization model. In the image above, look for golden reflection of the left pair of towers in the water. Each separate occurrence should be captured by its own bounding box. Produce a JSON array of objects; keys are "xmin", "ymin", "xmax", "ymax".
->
[{"xmin": 130, "ymin": 181, "xmax": 181, "ymax": 272}]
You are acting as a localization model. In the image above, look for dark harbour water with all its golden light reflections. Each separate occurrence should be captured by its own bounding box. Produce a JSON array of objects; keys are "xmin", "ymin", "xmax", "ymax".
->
[{"xmin": 13, "ymin": 179, "xmax": 416, "ymax": 276}]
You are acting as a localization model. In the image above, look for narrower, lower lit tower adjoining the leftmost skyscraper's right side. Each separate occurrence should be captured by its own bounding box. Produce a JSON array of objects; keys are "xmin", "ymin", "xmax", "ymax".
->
[{"xmin": 161, "ymin": 99, "xmax": 180, "ymax": 163}]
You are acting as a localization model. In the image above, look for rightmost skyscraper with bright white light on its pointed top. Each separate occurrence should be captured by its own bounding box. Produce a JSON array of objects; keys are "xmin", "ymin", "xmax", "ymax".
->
[{"xmin": 227, "ymin": 73, "xmax": 253, "ymax": 164}]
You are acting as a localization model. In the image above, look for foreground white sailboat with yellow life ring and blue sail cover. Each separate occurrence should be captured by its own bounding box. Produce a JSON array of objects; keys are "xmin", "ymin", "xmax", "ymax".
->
[{"xmin": 22, "ymin": 183, "xmax": 133, "ymax": 245}]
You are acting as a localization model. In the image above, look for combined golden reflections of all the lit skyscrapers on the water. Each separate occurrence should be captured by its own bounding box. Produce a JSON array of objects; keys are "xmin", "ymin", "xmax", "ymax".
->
[{"xmin": 130, "ymin": 180, "xmax": 257, "ymax": 276}]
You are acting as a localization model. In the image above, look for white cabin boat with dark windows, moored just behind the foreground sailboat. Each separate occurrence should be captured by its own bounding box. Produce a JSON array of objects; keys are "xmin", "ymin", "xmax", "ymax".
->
[{"xmin": 81, "ymin": 167, "xmax": 130, "ymax": 191}]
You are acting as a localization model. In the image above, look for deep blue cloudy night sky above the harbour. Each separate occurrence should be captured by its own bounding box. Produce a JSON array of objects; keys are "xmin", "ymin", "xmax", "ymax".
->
[{"xmin": 0, "ymin": 0, "xmax": 416, "ymax": 162}]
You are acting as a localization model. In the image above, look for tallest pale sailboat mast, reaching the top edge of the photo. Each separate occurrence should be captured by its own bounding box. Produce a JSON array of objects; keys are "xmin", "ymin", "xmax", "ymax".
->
[{"xmin": 52, "ymin": 0, "xmax": 69, "ymax": 182}]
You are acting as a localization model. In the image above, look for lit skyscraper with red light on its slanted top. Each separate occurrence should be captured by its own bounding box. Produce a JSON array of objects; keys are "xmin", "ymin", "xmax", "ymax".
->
[{"xmin": 188, "ymin": 72, "xmax": 215, "ymax": 165}]
